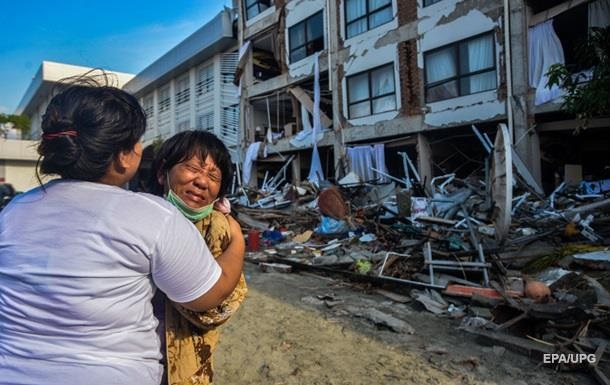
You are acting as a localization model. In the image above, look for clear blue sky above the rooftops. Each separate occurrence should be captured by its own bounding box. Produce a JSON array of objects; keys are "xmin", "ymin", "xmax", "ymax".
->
[{"xmin": 0, "ymin": 0, "xmax": 232, "ymax": 114}]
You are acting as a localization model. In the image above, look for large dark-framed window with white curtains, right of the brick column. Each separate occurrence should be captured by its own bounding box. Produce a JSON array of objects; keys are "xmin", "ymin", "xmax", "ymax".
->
[{"xmin": 424, "ymin": 33, "xmax": 496, "ymax": 102}]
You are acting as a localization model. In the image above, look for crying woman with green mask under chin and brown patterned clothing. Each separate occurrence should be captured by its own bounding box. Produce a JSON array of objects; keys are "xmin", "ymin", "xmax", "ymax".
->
[{"xmin": 150, "ymin": 131, "xmax": 247, "ymax": 385}]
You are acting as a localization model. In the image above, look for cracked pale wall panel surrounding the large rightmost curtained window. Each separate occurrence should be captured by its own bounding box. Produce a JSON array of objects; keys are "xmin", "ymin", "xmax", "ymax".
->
[{"xmin": 418, "ymin": 0, "xmax": 506, "ymax": 127}]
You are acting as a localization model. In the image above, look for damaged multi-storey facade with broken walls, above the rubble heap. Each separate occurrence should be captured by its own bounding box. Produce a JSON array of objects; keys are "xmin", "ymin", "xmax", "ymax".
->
[{"xmin": 237, "ymin": 0, "xmax": 610, "ymax": 195}]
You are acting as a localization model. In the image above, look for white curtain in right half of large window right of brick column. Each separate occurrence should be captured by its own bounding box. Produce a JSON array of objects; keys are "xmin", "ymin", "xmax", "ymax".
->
[{"xmin": 462, "ymin": 35, "xmax": 496, "ymax": 94}]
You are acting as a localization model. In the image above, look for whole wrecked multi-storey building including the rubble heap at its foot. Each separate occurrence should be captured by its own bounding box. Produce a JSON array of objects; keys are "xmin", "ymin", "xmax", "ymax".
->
[{"xmin": 235, "ymin": 0, "xmax": 610, "ymax": 384}]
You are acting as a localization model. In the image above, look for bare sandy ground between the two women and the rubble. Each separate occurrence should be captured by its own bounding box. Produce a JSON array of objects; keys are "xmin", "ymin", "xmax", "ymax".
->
[{"xmin": 214, "ymin": 263, "xmax": 594, "ymax": 385}]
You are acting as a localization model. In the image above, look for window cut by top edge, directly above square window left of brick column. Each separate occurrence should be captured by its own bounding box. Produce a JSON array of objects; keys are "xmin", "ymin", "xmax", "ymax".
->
[{"xmin": 345, "ymin": 0, "xmax": 392, "ymax": 39}]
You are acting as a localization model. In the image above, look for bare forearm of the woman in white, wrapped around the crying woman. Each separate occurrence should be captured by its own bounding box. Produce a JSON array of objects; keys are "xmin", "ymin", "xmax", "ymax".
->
[{"xmin": 181, "ymin": 216, "xmax": 246, "ymax": 311}]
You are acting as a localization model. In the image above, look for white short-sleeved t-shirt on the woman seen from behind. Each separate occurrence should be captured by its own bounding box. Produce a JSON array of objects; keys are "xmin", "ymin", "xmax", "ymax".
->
[{"xmin": 0, "ymin": 180, "xmax": 221, "ymax": 385}]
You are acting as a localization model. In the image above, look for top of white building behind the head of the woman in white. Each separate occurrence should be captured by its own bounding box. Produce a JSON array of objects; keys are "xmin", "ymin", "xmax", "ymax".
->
[{"xmin": 15, "ymin": 61, "xmax": 134, "ymax": 139}]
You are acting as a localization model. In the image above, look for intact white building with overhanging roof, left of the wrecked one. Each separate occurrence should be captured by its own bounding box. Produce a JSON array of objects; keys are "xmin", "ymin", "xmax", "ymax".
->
[{"xmin": 123, "ymin": 8, "xmax": 239, "ymax": 162}]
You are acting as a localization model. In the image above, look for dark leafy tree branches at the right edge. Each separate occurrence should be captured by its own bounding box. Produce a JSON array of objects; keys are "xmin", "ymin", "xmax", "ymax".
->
[{"xmin": 547, "ymin": 27, "xmax": 610, "ymax": 132}]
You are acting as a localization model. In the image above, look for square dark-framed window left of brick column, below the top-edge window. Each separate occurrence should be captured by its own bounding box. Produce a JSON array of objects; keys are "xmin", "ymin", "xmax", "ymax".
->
[{"xmin": 347, "ymin": 63, "xmax": 396, "ymax": 119}]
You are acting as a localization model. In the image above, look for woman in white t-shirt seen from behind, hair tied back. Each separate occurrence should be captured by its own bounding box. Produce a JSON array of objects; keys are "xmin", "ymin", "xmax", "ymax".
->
[{"xmin": 0, "ymin": 84, "xmax": 245, "ymax": 385}]
